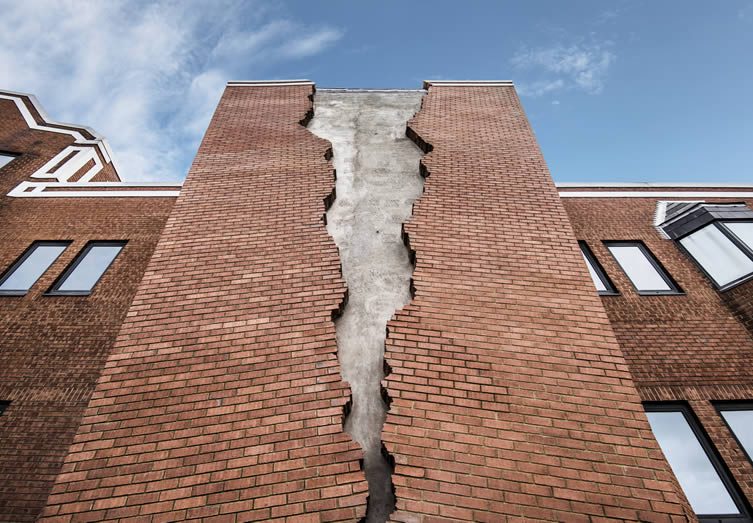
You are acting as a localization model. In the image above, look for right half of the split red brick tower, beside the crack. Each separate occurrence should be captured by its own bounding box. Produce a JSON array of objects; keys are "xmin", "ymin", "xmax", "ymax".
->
[{"xmin": 383, "ymin": 85, "xmax": 692, "ymax": 522}]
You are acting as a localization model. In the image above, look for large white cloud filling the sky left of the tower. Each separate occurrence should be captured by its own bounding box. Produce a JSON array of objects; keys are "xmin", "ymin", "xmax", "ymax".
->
[{"xmin": 0, "ymin": 0, "xmax": 343, "ymax": 180}]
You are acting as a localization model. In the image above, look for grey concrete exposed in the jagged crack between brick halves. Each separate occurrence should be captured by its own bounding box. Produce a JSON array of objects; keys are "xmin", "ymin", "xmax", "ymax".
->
[{"xmin": 308, "ymin": 90, "xmax": 423, "ymax": 522}]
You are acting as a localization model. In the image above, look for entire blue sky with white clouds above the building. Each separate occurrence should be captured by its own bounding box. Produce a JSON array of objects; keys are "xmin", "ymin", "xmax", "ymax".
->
[{"xmin": 0, "ymin": 0, "xmax": 753, "ymax": 183}]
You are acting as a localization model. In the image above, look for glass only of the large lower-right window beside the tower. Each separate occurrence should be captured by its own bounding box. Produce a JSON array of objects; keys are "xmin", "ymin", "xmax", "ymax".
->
[{"xmin": 646, "ymin": 412, "xmax": 739, "ymax": 515}]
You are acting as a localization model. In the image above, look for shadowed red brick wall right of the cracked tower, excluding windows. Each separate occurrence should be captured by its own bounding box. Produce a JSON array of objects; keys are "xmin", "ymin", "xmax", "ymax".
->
[{"xmin": 562, "ymin": 194, "xmax": 753, "ymax": 510}]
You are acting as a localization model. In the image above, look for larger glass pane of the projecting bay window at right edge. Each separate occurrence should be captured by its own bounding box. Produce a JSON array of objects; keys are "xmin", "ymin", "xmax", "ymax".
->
[{"xmin": 680, "ymin": 225, "xmax": 753, "ymax": 286}]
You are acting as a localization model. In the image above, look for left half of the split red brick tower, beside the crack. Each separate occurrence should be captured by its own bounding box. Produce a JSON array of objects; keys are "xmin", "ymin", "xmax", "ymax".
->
[{"xmin": 43, "ymin": 85, "xmax": 366, "ymax": 521}]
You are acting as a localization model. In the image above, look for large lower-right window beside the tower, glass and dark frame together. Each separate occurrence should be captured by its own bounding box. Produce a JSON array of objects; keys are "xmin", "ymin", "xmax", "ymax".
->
[{"xmin": 646, "ymin": 403, "xmax": 749, "ymax": 522}]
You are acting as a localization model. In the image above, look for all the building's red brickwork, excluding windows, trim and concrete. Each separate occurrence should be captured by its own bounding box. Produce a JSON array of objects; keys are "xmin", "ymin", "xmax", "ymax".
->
[{"xmin": 0, "ymin": 82, "xmax": 753, "ymax": 522}]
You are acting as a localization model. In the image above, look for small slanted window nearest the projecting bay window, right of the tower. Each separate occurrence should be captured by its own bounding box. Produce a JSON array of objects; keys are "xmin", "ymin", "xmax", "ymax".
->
[{"xmin": 604, "ymin": 241, "xmax": 681, "ymax": 294}]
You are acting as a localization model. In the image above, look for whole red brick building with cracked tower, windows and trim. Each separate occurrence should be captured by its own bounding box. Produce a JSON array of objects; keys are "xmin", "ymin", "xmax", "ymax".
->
[{"xmin": 0, "ymin": 80, "xmax": 753, "ymax": 522}]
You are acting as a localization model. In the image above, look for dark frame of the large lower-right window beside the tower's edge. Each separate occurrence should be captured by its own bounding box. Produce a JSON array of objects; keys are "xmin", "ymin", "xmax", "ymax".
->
[{"xmin": 643, "ymin": 401, "xmax": 753, "ymax": 523}]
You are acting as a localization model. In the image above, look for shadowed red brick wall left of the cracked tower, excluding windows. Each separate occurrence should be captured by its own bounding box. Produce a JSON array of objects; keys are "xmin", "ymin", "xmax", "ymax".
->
[{"xmin": 0, "ymin": 101, "xmax": 174, "ymax": 522}]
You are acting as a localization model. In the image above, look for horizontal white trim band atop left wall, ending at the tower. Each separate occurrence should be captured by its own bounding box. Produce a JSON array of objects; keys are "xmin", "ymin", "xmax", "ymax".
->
[{"xmin": 8, "ymin": 182, "xmax": 183, "ymax": 198}]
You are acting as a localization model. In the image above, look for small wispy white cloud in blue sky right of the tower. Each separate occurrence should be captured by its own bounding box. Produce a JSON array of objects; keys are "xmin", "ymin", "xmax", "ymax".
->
[{"xmin": 511, "ymin": 42, "xmax": 616, "ymax": 96}]
